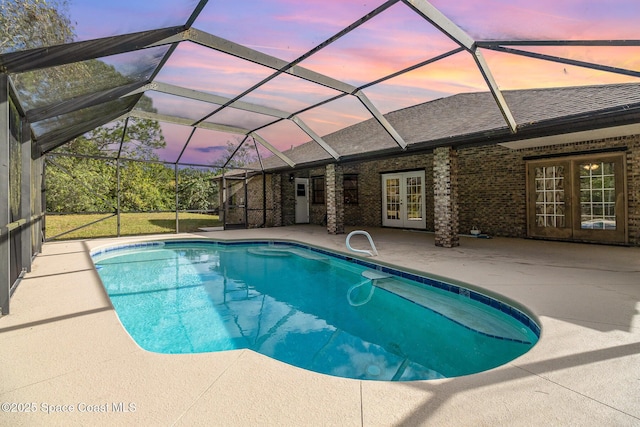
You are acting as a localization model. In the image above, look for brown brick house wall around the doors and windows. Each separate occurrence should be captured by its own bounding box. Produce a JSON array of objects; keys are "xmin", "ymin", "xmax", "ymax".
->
[{"xmin": 252, "ymin": 135, "xmax": 640, "ymax": 246}]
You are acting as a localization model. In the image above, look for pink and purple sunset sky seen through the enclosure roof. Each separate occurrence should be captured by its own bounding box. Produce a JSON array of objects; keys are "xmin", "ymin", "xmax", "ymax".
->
[{"xmin": 70, "ymin": 0, "xmax": 640, "ymax": 165}]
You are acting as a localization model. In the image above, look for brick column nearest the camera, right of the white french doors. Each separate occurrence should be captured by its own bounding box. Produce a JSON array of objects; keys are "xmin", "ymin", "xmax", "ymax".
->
[{"xmin": 433, "ymin": 147, "xmax": 460, "ymax": 248}]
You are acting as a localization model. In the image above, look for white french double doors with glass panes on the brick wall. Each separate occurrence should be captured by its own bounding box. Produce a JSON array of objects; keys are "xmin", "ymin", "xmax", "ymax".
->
[{"xmin": 382, "ymin": 171, "xmax": 427, "ymax": 228}]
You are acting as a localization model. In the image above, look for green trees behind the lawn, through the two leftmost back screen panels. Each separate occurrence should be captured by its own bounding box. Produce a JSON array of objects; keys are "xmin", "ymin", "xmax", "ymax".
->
[{"xmin": 46, "ymin": 113, "xmax": 175, "ymax": 212}]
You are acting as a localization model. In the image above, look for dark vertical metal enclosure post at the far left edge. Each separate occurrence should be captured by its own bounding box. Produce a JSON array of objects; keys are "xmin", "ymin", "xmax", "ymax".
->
[{"xmin": 0, "ymin": 73, "xmax": 11, "ymax": 314}]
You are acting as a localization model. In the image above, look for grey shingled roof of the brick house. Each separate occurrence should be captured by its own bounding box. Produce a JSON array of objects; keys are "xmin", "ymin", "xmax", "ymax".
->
[{"xmin": 264, "ymin": 83, "xmax": 640, "ymax": 170}]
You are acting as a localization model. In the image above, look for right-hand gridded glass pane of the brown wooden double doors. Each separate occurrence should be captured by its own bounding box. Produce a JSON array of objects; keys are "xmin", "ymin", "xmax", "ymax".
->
[{"xmin": 579, "ymin": 162, "xmax": 616, "ymax": 230}]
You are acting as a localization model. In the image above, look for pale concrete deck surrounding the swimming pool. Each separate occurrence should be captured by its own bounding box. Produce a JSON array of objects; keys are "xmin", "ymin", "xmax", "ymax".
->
[{"xmin": 0, "ymin": 226, "xmax": 640, "ymax": 426}]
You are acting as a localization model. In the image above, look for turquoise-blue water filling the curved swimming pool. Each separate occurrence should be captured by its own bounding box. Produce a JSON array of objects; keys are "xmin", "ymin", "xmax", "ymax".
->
[{"xmin": 92, "ymin": 240, "xmax": 540, "ymax": 381}]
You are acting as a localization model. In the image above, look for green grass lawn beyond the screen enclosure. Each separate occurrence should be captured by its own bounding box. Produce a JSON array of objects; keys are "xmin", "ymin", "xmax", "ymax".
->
[{"xmin": 46, "ymin": 212, "xmax": 222, "ymax": 240}]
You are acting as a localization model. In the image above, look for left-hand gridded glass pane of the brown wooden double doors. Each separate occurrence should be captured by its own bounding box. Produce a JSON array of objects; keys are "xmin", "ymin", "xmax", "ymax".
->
[{"xmin": 535, "ymin": 166, "xmax": 566, "ymax": 228}]
